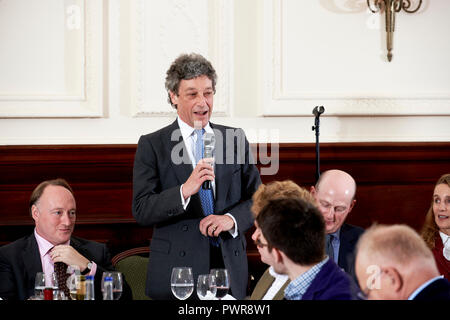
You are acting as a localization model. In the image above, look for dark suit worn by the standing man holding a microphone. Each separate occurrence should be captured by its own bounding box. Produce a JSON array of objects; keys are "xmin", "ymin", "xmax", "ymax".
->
[{"xmin": 133, "ymin": 121, "xmax": 261, "ymax": 300}]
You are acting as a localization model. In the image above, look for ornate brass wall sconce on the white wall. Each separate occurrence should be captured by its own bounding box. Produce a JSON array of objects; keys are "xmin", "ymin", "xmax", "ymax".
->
[{"xmin": 367, "ymin": 0, "xmax": 422, "ymax": 62}]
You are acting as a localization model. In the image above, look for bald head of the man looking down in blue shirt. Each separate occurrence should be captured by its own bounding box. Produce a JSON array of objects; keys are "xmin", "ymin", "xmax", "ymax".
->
[{"xmin": 311, "ymin": 170, "xmax": 356, "ymax": 234}]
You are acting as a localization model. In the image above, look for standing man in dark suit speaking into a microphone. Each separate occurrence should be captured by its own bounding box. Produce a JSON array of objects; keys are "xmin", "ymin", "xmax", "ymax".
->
[{"xmin": 133, "ymin": 54, "xmax": 261, "ymax": 299}]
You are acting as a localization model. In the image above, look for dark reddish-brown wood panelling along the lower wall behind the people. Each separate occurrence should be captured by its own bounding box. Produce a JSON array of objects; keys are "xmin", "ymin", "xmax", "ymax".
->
[{"xmin": 0, "ymin": 143, "xmax": 450, "ymax": 280}]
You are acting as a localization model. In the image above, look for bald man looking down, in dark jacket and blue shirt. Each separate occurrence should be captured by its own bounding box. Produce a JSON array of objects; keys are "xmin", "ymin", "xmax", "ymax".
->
[{"xmin": 310, "ymin": 170, "xmax": 364, "ymax": 280}]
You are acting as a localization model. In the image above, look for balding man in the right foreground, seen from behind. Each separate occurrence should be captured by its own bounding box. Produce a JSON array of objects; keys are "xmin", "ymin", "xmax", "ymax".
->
[{"xmin": 356, "ymin": 225, "xmax": 450, "ymax": 301}]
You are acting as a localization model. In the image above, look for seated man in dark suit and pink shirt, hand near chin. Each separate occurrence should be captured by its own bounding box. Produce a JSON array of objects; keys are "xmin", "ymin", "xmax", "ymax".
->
[{"xmin": 0, "ymin": 179, "xmax": 131, "ymax": 300}]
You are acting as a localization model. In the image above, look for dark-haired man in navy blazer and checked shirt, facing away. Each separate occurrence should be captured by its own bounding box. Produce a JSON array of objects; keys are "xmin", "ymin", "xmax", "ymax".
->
[{"xmin": 255, "ymin": 198, "xmax": 352, "ymax": 300}]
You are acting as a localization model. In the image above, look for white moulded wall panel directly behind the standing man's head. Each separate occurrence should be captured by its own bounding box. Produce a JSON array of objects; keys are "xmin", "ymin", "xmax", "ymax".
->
[{"xmin": 129, "ymin": 0, "xmax": 234, "ymax": 117}]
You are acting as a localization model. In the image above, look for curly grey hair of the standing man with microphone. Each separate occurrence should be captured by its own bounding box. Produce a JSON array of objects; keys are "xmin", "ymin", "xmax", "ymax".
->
[{"xmin": 165, "ymin": 53, "xmax": 217, "ymax": 109}]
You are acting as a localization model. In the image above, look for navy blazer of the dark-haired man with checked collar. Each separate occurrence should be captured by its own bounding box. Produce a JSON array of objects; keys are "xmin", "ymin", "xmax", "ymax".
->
[{"xmin": 302, "ymin": 259, "xmax": 352, "ymax": 300}]
